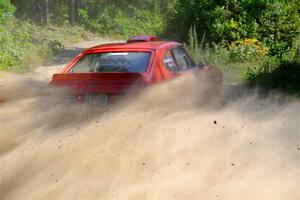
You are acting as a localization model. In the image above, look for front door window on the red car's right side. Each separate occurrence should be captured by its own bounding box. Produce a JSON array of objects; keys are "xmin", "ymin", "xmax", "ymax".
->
[{"xmin": 172, "ymin": 47, "xmax": 195, "ymax": 71}]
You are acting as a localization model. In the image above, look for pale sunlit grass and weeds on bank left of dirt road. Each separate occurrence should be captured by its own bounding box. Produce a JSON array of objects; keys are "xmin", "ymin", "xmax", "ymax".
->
[{"xmin": 0, "ymin": 21, "xmax": 93, "ymax": 73}]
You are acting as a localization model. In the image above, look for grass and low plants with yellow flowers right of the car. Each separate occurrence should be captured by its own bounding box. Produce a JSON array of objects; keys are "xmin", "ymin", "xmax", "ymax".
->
[{"xmin": 188, "ymin": 28, "xmax": 300, "ymax": 96}]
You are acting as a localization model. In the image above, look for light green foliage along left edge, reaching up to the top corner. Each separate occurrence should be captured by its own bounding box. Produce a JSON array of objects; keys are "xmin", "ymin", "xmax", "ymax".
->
[{"xmin": 0, "ymin": 1, "xmax": 84, "ymax": 71}]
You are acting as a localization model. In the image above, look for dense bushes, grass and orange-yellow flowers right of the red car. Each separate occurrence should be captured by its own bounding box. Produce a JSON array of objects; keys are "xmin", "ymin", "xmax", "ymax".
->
[{"xmin": 178, "ymin": 0, "xmax": 300, "ymax": 95}]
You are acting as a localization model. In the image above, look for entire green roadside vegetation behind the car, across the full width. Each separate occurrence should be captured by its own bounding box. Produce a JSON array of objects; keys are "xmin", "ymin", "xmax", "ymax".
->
[{"xmin": 0, "ymin": 0, "xmax": 300, "ymax": 94}]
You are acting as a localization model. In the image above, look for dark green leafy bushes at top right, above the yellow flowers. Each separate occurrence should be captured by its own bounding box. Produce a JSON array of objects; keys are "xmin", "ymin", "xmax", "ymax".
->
[{"xmin": 168, "ymin": 0, "xmax": 300, "ymax": 57}]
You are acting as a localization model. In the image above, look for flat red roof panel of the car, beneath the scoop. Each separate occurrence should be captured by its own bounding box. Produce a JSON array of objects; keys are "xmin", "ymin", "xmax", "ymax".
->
[{"xmin": 86, "ymin": 41, "xmax": 180, "ymax": 51}]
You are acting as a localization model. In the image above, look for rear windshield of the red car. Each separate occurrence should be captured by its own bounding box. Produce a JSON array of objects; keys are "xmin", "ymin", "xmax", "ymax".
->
[{"xmin": 69, "ymin": 52, "xmax": 150, "ymax": 73}]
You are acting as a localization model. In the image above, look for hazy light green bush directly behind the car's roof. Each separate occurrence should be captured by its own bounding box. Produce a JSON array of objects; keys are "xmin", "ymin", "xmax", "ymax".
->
[{"xmin": 80, "ymin": 4, "xmax": 165, "ymax": 37}]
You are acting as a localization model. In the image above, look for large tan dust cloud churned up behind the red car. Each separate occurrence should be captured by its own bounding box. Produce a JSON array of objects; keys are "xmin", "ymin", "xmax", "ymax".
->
[{"xmin": 0, "ymin": 73, "xmax": 300, "ymax": 200}]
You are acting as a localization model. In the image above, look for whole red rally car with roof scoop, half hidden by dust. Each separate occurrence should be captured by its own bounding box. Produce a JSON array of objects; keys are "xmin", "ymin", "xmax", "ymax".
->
[{"xmin": 51, "ymin": 36, "xmax": 222, "ymax": 105}]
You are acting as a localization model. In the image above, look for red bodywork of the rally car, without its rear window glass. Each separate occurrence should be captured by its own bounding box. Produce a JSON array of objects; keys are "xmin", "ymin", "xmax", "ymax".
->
[{"xmin": 51, "ymin": 36, "xmax": 222, "ymax": 104}]
